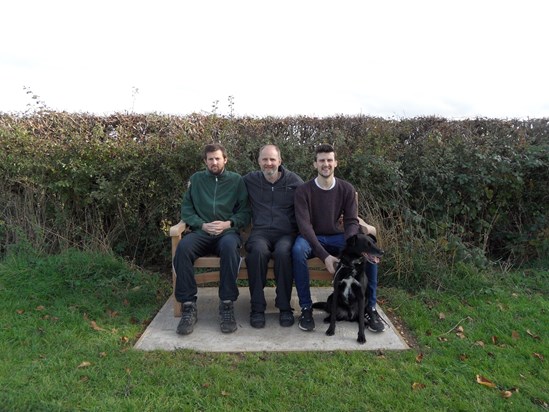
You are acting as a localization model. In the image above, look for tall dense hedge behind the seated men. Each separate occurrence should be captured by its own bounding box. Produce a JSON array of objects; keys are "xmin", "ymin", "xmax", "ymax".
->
[{"xmin": 0, "ymin": 112, "xmax": 549, "ymax": 282}]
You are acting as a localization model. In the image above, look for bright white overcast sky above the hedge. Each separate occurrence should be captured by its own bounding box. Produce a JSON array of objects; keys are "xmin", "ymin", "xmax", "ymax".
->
[{"xmin": 0, "ymin": 0, "xmax": 549, "ymax": 118}]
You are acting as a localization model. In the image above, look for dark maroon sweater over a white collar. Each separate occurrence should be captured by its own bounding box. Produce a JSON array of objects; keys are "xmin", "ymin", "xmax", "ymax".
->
[{"xmin": 294, "ymin": 178, "xmax": 359, "ymax": 261}]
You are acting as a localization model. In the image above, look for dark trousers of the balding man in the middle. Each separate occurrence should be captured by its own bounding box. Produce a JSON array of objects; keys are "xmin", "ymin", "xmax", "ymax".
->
[{"xmin": 246, "ymin": 231, "xmax": 295, "ymax": 312}]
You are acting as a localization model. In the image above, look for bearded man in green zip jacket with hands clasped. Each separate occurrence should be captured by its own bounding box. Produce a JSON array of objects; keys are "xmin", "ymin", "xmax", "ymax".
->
[{"xmin": 173, "ymin": 143, "xmax": 251, "ymax": 335}]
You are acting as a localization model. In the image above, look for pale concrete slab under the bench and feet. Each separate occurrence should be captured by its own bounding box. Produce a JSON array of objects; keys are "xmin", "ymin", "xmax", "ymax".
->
[{"xmin": 135, "ymin": 287, "xmax": 409, "ymax": 352}]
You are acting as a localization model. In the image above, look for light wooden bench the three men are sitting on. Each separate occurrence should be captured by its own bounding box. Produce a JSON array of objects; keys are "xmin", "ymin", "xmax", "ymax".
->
[{"xmin": 170, "ymin": 217, "xmax": 376, "ymax": 317}]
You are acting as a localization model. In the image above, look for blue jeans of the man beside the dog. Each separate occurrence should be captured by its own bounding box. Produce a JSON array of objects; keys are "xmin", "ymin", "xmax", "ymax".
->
[{"xmin": 292, "ymin": 233, "xmax": 377, "ymax": 308}]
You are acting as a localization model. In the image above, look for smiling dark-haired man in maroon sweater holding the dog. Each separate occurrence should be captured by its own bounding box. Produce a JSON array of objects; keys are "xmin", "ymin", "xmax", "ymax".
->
[{"xmin": 292, "ymin": 144, "xmax": 385, "ymax": 332}]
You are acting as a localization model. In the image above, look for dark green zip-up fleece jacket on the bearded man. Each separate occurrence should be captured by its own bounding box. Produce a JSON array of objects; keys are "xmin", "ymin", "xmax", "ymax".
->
[{"xmin": 181, "ymin": 170, "xmax": 251, "ymax": 231}]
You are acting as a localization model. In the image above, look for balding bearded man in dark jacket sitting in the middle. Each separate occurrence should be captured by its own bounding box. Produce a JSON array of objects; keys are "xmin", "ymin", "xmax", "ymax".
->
[{"xmin": 244, "ymin": 145, "xmax": 303, "ymax": 328}]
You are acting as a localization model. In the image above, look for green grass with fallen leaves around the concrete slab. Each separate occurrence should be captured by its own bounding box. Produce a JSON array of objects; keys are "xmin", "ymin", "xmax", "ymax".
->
[{"xmin": 0, "ymin": 251, "xmax": 549, "ymax": 411}]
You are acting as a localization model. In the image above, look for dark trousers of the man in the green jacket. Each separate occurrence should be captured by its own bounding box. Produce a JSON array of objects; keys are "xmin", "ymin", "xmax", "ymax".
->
[{"xmin": 173, "ymin": 231, "xmax": 241, "ymax": 303}]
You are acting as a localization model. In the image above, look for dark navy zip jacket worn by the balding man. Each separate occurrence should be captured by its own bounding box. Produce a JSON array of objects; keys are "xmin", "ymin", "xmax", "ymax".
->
[{"xmin": 244, "ymin": 166, "xmax": 303, "ymax": 234}]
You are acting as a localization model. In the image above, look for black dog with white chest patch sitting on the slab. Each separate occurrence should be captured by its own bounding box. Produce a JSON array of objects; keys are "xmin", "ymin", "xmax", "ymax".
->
[{"xmin": 313, "ymin": 233, "xmax": 384, "ymax": 343}]
